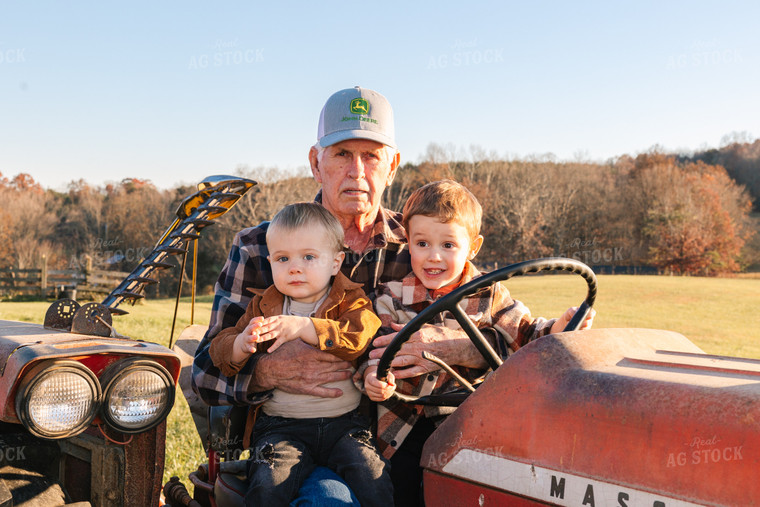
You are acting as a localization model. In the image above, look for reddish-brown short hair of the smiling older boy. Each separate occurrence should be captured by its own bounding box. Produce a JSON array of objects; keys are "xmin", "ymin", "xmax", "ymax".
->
[{"xmin": 403, "ymin": 180, "xmax": 483, "ymax": 239}]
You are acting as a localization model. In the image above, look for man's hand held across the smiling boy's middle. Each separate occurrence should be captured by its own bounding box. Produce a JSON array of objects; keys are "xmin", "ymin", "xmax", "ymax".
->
[{"xmin": 369, "ymin": 324, "xmax": 488, "ymax": 379}]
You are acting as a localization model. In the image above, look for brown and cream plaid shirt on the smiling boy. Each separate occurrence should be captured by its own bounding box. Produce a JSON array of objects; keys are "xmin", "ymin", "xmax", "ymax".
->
[{"xmin": 359, "ymin": 261, "xmax": 555, "ymax": 459}]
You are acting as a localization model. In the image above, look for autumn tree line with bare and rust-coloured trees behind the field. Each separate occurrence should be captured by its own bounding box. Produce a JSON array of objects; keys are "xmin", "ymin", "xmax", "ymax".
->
[{"xmin": 0, "ymin": 140, "xmax": 760, "ymax": 295}]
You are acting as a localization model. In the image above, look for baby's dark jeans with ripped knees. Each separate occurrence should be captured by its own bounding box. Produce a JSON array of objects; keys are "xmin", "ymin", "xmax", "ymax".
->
[{"xmin": 245, "ymin": 411, "xmax": 393, "ymax": 507}]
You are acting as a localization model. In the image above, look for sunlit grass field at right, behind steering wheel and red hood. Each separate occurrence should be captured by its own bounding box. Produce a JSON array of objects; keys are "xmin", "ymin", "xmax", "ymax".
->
[{"xmin": 506, "ymin": 274, "xmax": 760, "ymax": 359}]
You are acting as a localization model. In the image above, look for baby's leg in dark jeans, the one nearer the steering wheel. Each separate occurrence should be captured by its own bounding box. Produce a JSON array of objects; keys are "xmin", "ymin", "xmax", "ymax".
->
[{"xmin": 327, "ymin": 413, "xmax": 393, "ymax": 507}]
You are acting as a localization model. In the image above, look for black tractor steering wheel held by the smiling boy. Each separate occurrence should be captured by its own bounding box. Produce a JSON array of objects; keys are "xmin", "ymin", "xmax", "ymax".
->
[{"xmin": 377, "ymin": 257, "xmax": 597, "ymax": 406}]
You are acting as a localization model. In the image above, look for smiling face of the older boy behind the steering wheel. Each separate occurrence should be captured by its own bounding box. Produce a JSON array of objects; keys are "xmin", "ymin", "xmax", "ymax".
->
[{"xmin": 406, "ymin": 215, "xmax": 483, "ymax": 290}]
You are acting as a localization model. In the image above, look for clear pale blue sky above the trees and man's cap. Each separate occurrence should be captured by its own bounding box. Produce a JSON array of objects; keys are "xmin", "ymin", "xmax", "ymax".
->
[{"xmin": 0, "ymin": 0, "xmax": 760, "ymax": 189}]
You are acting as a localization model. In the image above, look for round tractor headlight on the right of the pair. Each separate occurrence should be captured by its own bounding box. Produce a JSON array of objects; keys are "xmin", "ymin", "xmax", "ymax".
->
[{"xmin": 101, "ymin": 359, "xmax": 174, "ymax": 433}]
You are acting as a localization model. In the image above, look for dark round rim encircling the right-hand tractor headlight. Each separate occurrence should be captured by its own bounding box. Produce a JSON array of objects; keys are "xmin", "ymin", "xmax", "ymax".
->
[{"xmin": 100, "ymin": 358, "xmax": 176, "ymax": 433}]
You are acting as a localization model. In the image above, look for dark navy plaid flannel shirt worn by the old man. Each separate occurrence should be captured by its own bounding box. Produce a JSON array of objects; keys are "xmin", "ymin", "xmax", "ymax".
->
[{"xmin": 193, "ymin": 196, "xmax": 411, "ymax": 405}]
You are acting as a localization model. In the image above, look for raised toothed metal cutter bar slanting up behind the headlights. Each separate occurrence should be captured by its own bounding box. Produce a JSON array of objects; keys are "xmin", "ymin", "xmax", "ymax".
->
[{"xmin": 44, "ymin": 176, "xmax": 256, "ymax": 336}]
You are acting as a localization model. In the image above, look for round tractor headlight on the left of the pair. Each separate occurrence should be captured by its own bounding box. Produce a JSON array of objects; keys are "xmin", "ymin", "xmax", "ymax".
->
[{"xmin": 16, "ymin": 361, "xmax": 101, "ymax": 439}]
